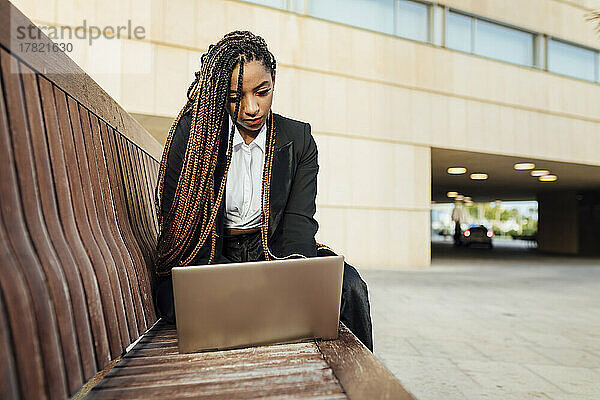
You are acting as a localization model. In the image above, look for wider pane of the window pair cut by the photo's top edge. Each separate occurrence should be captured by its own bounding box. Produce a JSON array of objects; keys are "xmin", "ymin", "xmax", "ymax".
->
[{"xmin": 309, "ymin": 0, "xmax": 395, "ymax": 34}]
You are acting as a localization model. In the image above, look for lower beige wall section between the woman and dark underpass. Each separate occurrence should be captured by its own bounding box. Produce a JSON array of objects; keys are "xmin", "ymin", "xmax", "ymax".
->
[{"xmin": 315, "ymin": 133, "xmax": 431, "ymax": 268}]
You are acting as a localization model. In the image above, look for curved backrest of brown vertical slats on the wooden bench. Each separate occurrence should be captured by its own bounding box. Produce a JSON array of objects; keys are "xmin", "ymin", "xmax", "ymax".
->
[{"xmin": 0, "ymin": 0, "xmax": 158, "ymax": 399}]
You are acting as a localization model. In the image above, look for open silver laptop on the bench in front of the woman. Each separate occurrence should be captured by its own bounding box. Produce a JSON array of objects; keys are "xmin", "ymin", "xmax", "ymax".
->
[{"xmin": 172, "ymin": 256, "xmax": 344, "ymax": 353}]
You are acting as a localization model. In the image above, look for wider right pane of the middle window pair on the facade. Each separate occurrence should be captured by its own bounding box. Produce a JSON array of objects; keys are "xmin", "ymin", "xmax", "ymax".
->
[{"xmin": 475, "ymin": 20, "xmax": 533, "ymax": 65}]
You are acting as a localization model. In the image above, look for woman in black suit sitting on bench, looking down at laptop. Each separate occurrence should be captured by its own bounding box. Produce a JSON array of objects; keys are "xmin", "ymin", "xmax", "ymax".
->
[{"xmin": 155, "ymin": 31, "xmax": 373, "ymax": 351}]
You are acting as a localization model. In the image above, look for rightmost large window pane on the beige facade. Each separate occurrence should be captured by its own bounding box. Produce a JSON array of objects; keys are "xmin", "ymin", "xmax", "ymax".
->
[{"xmin": 548, "ymin": 39, "xmax": 600, "ymax": 81}]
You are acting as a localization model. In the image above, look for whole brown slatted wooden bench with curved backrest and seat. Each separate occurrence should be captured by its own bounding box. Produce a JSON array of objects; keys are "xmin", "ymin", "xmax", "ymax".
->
[{"xmin": 0, "ymin": 0, "xmax": 412, "ymax": 399}]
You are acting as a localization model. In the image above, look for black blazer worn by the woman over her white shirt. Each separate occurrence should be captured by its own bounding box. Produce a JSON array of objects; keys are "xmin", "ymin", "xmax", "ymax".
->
[{"xmin": 158, "ymin": 111, "xmax": 319, "ymax": 275}]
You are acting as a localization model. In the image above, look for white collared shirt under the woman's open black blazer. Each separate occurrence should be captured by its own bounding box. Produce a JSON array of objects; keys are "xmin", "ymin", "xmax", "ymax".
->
[{"xmin": 225, "ymin": 116, "xmax": 267, "ymax": 229}]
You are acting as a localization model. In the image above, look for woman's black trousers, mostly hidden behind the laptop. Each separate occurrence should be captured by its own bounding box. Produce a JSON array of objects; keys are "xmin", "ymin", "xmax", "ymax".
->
[{"xmin": 154, "ymin": 232, "xmax": 373, "ymax": 351}]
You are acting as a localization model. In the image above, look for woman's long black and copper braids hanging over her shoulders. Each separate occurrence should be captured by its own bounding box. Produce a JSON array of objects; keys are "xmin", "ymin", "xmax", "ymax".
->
[{"xmin": 155, "ymin": 31, "xmax": 276, "ymax": 275}]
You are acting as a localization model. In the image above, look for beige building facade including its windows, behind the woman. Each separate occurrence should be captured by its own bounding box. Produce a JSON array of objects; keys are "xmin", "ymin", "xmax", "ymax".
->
[{"xmin": 15, "ymin": 0, "xmax": 600, "ymax": 268}]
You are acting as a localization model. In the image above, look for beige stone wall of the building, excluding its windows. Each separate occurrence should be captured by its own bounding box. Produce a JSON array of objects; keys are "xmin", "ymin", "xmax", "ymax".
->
[{"xmin": 16, "ymin": 0, "xmax": 600, "ymax": 268}]
